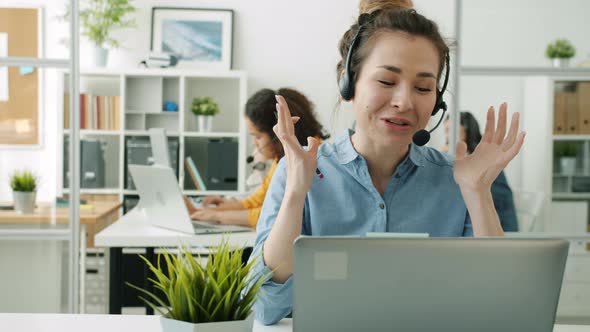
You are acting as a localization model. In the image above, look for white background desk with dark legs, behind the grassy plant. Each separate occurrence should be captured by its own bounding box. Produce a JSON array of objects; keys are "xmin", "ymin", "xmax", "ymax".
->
[{"xmin": 94, "ymin": 211, "xmax": 256, "ymax": 314}]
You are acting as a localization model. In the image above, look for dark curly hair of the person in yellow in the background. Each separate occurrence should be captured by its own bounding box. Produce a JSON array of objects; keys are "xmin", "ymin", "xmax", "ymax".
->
[{"xmin": 246, "ymin": 88, "xmax": 330, "ymax": 158}]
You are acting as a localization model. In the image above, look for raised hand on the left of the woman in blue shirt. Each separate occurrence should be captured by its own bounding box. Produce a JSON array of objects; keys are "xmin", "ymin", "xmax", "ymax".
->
[{"xmin": 273, "ymin": 95, "xmax": 320, "ymax": 196}]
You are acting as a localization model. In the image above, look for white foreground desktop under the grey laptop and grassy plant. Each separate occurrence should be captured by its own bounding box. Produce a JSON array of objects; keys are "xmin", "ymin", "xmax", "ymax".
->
[{"xmin": 0, "ymin": 314, "xmax": 590, "ymax": 332}]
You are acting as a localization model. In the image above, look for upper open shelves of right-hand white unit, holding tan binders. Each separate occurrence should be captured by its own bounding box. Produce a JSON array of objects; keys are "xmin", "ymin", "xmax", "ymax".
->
[{"xmin": 522, "ymin": 75, "xmax": 590, "ymax": 211}]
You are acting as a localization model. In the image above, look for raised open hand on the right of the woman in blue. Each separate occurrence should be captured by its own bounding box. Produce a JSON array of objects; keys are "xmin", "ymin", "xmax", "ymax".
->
[{"xmin": 454, "ymin": 103, "xmax": 525, "ymax": 193}]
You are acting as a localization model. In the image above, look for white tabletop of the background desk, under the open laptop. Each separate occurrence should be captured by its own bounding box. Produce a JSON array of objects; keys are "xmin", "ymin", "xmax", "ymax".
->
[{"xmin": 94, "ymin": 213, "xmax": 256, "ymax": 248}]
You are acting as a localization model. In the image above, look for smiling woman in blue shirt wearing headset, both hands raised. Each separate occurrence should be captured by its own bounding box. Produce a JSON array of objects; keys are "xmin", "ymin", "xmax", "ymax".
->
[{"xmin": 253, "ymin": 5, "xmax": 524, "ymax": 324}]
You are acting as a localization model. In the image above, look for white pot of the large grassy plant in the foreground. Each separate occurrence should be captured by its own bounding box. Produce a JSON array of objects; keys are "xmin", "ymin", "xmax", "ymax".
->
[{"xmin": 160, "ymin": 312, "xmax": 254, "ymax": 332}]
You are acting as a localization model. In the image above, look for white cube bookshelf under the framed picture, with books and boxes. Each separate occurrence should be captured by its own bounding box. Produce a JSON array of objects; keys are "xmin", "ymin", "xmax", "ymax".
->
[{"xmin": 58, "ymin": 68, "xmax": 247, "ymax": 213}]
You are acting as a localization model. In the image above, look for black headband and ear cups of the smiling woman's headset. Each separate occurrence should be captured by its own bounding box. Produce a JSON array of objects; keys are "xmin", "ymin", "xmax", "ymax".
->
[{"xmin": 338, "ymin": 11, "xmax": 450, "ymax": 115}]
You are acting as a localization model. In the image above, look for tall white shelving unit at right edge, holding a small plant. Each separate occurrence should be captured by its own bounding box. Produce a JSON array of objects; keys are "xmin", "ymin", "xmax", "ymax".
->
[{"xmin": 522, "ymin": 74, "xmax": 590, "ymax": 319}]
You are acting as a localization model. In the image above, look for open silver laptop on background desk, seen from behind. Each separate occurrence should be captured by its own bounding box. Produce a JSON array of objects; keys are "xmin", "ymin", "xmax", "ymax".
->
[{"xmin": 129, "ymin": 165, "xmax": 253, "ymax": 234}]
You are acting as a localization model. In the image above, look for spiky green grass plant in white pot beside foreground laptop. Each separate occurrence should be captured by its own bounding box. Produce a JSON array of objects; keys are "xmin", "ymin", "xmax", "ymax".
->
[{"xmin": 127, "ymin": 238, "xmax": 268, "ymax": 332}]
